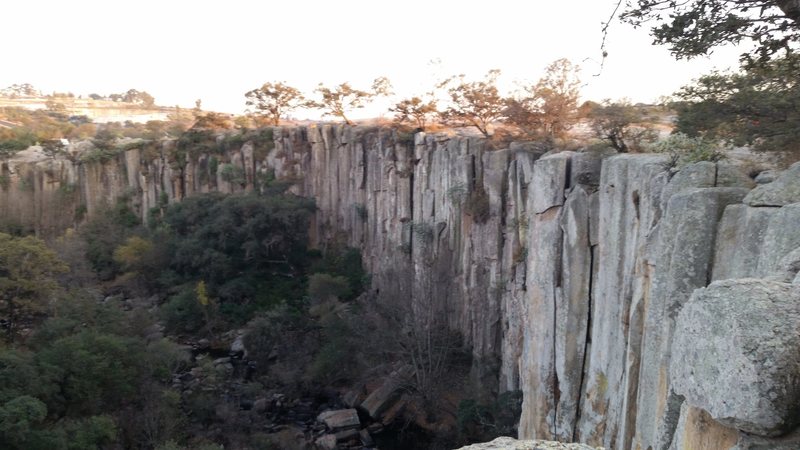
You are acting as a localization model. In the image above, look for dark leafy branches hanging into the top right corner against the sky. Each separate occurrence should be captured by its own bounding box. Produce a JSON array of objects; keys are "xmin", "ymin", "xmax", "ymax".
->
[{"xmin": 617, "ymin": 0, "xmax": 800, "ymax": 63}]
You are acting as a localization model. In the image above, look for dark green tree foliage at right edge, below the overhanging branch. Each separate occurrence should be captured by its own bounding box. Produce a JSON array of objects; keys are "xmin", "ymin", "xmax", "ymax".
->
[{"xmin": 673, "ymin": 56, "xmax": 800, "ymax": 150}]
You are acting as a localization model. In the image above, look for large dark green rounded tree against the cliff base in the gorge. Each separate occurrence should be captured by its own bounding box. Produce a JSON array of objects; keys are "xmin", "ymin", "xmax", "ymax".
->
[{"xmin": 156, "ymin": 194, "xmax": 315, "ymax": 321}]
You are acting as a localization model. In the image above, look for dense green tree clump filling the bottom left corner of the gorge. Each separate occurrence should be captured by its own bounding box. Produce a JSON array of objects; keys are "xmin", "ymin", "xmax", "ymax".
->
[{"xmin": 0, "ymin": 296, "xmax": 188, "ymax": 450}]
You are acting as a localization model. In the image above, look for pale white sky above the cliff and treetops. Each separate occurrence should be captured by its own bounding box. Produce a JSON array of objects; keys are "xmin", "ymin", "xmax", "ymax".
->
[{"xmin": 0, "ymin": 0, "xmax": 740, "ymax": 118}]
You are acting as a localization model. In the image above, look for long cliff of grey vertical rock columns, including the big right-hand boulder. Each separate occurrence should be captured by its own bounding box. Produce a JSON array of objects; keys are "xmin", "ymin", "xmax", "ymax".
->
[{"xmin": 0, "ymin": 125, "xmax": 800, "ymax": 450}]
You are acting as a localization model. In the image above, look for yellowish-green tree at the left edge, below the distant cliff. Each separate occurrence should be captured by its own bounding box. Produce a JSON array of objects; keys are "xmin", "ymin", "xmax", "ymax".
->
[{"xmin": 0, "ymin": 233, "xmax": 68, "ymax": 340}]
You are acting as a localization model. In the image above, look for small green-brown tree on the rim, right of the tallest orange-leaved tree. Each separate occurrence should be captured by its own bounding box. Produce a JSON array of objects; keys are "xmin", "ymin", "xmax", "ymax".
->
[{"xmin": 589, "ymin": 100, "xmax": 655, "ymax": 153}]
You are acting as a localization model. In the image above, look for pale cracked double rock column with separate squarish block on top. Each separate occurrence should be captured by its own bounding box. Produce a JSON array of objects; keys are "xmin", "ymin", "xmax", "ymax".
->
[{"xmin": 519, "ymin": 152, "xmax": 600, "ymax": 441}]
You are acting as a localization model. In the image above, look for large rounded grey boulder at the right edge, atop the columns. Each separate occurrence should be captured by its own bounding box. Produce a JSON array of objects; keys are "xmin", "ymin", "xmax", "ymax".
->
[{"xmin": 670, "ymin": 279, "xmax": 800, "ymax": 436}]
